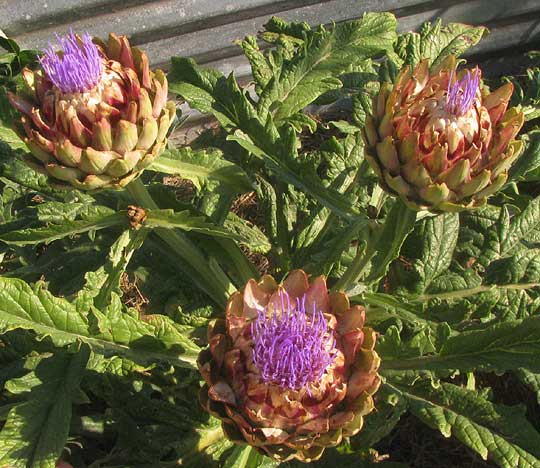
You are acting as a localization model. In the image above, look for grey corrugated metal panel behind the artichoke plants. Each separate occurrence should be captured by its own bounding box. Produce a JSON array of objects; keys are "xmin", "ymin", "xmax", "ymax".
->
[{"xmin": 0, "ymin": 0, "xmax": 540, "ymax": 77}]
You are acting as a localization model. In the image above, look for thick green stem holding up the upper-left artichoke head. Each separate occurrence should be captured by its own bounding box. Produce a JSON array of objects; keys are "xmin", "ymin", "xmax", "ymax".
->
[{"xmin": 126, "ymin": 179, "xmax": 235, "ymax": 306}]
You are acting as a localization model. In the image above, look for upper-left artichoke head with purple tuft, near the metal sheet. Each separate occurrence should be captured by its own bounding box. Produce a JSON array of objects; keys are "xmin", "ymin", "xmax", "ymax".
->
[{"xmin": 9, "ymin": 32, "xmax": 175, "ymax": 190}]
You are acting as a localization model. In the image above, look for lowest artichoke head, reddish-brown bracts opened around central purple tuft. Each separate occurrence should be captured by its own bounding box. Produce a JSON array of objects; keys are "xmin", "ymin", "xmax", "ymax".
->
[{"xmin": 198, "ymin": 270, "xmax": 380, "ymax": 462}]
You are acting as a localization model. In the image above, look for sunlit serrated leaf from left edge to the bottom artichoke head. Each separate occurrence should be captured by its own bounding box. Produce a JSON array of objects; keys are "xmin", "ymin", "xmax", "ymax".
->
[{"xmin": 0, "ymin": 277, "xmax": 199, "ymax": 367}]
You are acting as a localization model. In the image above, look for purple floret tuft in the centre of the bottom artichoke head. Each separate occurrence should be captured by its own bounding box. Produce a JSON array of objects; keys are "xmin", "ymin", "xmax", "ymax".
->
[{"xmin": 251, "ymin": 293, "xmax": 335, "ymax": 390}]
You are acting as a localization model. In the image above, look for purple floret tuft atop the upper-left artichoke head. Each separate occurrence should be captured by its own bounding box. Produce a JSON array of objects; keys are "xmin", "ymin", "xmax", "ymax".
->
[{"xmin": 39, "ymin": 31, "xmax": 102, "ymax": 93}]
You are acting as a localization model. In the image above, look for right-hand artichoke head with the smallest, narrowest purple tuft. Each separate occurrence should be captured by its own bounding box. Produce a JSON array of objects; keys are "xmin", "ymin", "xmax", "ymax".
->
[{"xmin": 364, "ymin": 56, "xmax": 524, "ymax": 212}]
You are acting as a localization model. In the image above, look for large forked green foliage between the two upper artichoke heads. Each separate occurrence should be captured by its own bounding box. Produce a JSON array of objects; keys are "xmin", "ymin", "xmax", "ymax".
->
[{"xmin": 169, "ymin": 14, "xmax": 395, "ymax": 220}]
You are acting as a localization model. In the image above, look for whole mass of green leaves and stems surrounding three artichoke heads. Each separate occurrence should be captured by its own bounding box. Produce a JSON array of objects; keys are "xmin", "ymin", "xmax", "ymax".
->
[{"xmin": 0, "ymin": 13, "xmax": 540, "ymax": 468}]
